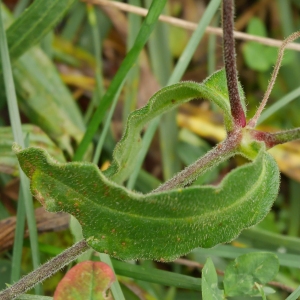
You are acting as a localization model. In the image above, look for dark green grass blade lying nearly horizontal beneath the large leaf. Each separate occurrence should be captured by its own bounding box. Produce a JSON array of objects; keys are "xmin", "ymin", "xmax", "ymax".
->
[{"xmin": 113, "ymin": 260, "xmax": 201, "ymax": 291}]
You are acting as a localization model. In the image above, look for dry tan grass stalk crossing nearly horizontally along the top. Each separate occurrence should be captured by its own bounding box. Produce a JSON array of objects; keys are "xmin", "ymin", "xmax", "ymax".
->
[{"xmin": 82, "ymin": 0, "xmax": 300, "ymax": 51}]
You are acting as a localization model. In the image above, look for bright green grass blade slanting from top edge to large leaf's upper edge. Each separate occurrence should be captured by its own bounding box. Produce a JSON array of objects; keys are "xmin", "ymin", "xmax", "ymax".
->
[{"xmin": 74, "ymin": 0, "xmax": 166, "ymax": 161}]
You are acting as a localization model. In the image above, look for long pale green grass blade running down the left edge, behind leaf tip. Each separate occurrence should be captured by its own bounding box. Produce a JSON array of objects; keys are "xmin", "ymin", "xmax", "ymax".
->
[{"xmin": 0, "ymin": 1, "xmax": 41, "ymax": 293}]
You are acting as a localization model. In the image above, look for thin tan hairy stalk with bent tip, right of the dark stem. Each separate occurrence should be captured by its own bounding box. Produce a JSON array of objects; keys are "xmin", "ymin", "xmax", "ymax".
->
[{"xmin": 248, "ymin": 31, "xmax": 300, "ymax": 128}]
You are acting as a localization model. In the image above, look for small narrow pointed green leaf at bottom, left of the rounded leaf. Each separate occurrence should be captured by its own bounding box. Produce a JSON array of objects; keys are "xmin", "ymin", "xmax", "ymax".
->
[{"xmin": 202, "ymin": 258, "xmax": 224, "ymax": 300}]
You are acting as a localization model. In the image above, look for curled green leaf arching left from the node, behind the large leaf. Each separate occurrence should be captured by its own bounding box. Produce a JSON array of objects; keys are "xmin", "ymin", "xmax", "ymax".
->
[{"xmin": 105, "ymin": 69, "xmax": 245, "ymax": 183}]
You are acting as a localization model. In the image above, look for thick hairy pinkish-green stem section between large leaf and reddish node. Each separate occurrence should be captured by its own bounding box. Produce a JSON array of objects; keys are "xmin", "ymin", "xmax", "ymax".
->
[{"xmin": 151, "ymin": 130, "xmax": 242, "ymax": 193}]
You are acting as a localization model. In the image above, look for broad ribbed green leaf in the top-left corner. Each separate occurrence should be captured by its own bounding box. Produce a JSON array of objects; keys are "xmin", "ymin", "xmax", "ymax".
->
[{"xmin": 7, "ymin": 0, "xmax": 76, "ymax": 61}]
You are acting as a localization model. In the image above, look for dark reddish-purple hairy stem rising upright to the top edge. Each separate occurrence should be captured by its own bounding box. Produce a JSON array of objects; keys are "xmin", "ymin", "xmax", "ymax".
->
[{"xmin": 223, "ymin": 0, "xmax": 246, "ymax": 127}]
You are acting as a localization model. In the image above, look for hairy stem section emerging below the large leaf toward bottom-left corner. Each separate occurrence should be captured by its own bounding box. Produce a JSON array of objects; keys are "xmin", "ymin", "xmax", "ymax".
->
[{"xmin": 0, "ymin": 240, "xmax": 90, "ymax": 300}]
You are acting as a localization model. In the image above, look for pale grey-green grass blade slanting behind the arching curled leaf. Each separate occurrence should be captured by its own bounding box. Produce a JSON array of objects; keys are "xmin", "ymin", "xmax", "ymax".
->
[{"xmin": 129, "ymin": 0, "xmax": 221, "ymax": 187}]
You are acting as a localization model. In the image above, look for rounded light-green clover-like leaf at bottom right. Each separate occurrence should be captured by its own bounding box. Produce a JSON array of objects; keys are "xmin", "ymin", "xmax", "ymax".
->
[{"xmin": 224, "ymin": 252, "xmax": 279, "ymax": 296}]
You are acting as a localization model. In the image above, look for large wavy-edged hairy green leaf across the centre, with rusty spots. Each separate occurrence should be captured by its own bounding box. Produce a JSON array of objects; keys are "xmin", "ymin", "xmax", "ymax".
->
[{"xmin": 14, "ymin": 146, "xmax": 279, "ymax": 261}]
